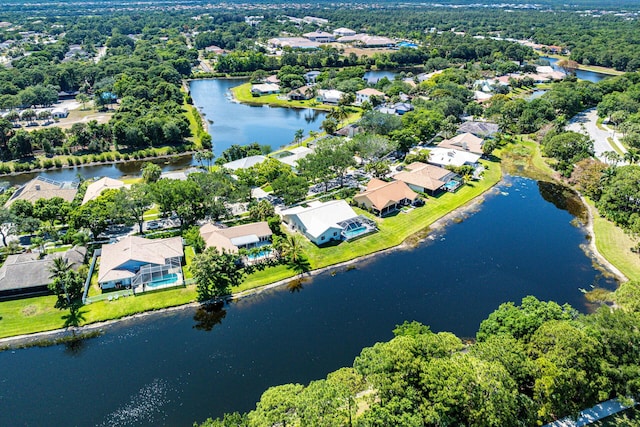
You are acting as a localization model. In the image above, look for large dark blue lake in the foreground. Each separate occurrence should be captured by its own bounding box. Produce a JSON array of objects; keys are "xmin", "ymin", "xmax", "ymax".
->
[{"xmin": 0, "ymin": 177, "xmax": 615, "ymax": 426}]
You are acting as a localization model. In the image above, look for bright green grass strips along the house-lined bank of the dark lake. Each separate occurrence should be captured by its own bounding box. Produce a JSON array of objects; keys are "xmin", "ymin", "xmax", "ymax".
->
[{"xmin": 0, "ymin": 157, "xmax": 502, "ymax": 338}]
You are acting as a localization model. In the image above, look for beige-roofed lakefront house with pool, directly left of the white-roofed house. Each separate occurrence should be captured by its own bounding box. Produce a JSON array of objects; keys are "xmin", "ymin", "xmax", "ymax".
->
[{"xmin": 200, "ymin": 221, "xmax": 273, "ymax": 253}]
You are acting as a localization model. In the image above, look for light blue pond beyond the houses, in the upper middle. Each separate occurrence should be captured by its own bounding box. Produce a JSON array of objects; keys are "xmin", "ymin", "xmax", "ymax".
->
[{"xmin": 190, "ymin": 79, "xmax": 326, "ymax": 156}]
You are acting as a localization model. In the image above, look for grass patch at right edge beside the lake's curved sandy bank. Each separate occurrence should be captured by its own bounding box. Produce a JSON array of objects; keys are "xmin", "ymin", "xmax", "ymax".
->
[{"xmin": 588, "ymin": 201, "xmax": 640, "ymax": 280}]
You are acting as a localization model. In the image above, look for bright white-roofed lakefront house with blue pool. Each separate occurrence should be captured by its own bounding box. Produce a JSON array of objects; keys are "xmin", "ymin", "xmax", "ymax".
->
[{"xmin": 280, "ymin": 200, "xmax": 376, "ymax": 245}]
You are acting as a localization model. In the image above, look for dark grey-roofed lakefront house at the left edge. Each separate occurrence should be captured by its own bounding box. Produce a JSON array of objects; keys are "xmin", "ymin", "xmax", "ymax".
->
[{"xmin": 0, "ymin": 246, "xmax": 87, "ymax": 299}]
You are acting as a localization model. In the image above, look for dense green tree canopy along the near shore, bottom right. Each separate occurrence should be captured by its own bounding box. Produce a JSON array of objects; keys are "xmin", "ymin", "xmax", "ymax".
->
[{"xmin": 202, "ymin": 288, "xmax": 640, "ymax": 427}]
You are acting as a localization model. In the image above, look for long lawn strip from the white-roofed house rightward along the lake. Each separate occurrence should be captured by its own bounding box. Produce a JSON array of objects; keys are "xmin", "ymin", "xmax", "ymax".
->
[{"xmin": 303, "ymin": 162, "xmax": 502, "ymax": 269}]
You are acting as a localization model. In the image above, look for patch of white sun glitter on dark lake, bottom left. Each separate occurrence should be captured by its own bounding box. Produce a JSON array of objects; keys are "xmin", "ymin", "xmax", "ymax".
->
[{"xmin": 97, "ymin": 378, "xmax": 170, "ymax": 427}]
